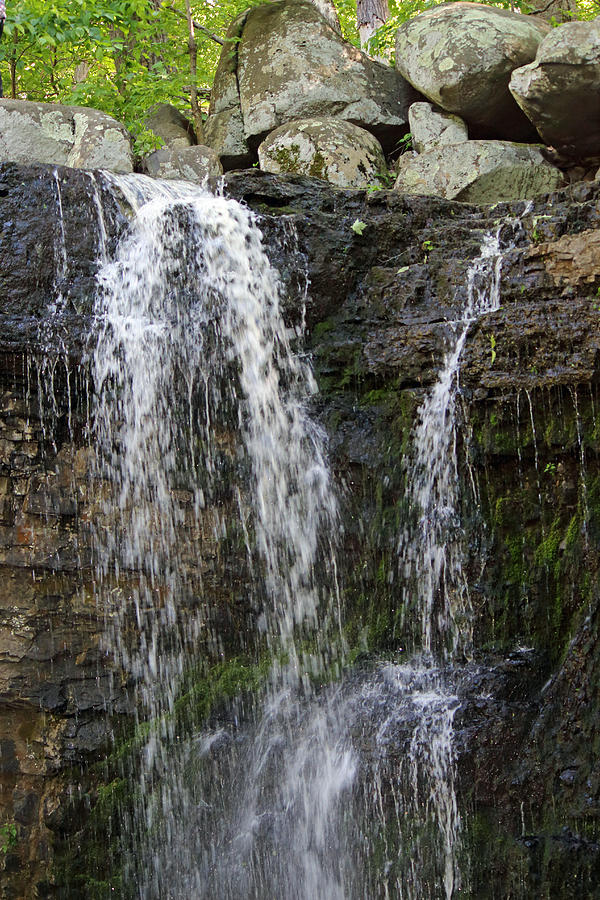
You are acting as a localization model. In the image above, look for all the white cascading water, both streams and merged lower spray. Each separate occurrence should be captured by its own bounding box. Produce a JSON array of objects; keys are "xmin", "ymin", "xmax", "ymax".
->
[{"xmin": 93, "ymin": 177, "xmax": 516, "ymax": 900}]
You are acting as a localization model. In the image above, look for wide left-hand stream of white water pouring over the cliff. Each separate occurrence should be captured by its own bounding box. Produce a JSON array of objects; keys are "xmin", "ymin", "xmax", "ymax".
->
[{"xmin": 92, "ymin": 177, "xmax": 337, "ymax": 897}]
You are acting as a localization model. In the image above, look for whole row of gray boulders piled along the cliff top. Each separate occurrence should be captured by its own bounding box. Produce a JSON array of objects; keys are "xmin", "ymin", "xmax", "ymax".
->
[{"xmin": 0, "ymin": 0, "xmax": 600, "ymax": 203}]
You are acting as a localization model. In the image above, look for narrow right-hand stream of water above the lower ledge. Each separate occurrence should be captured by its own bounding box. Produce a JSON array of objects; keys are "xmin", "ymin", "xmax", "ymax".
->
[{"xmin": 398, "ymin": 229, "xmax": 502, "ymax": 655}]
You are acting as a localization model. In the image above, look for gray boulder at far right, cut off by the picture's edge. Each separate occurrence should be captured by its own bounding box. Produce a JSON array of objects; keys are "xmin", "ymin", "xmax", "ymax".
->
[{"xmin": 510, "ymin": 19, "xmax": 600, "ymax": 157}]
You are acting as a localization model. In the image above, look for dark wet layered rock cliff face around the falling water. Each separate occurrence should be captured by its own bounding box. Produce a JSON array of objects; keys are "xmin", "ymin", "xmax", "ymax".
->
[{"xmin": 0, "ymin": 164, "xmax": 600, "ymax": 898}]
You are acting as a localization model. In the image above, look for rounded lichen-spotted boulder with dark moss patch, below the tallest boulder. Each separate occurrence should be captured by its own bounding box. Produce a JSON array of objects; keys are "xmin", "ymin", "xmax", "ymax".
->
[{"xmin": 258, "ymin": 118, "xmax": 386, "ymax": 188}]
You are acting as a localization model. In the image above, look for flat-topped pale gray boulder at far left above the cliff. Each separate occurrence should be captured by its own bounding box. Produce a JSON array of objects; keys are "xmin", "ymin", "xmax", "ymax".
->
[{"xmin": 0, "ymin": 100, "xmax": 133, "ymax": 173}]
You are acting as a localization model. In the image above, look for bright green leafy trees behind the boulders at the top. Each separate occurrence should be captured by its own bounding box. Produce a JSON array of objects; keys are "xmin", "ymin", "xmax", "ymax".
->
[{"xmin": 0, "ymin": 0, "xmax": 599, "ymax": 152}]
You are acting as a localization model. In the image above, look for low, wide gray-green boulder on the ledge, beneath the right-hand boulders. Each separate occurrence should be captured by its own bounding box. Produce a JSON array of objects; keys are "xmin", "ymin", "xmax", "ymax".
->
[{"xmin": 394, "ymin": 141, "xmax": 564, "ymax": 203}]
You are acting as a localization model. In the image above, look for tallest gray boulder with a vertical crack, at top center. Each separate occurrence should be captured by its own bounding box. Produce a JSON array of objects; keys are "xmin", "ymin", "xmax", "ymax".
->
[{"xmin": 205, "ymin": 0, "xmax": 418, "ymax": 168}]
